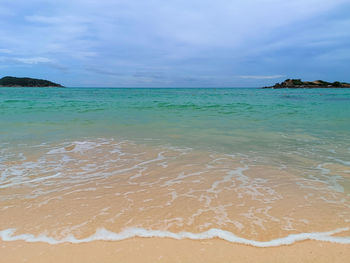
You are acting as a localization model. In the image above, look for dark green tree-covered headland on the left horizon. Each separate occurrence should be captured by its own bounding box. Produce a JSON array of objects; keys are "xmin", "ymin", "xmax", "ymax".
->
[{"xmin": 0, "ymin": 76, "xmax": 63, "ymax": 88}]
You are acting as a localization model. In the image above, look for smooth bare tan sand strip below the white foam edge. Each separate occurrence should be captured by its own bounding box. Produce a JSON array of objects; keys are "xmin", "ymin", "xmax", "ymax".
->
[{"xmin": 0, "ymin": 238, "xmax": 350, "ymax": 263}]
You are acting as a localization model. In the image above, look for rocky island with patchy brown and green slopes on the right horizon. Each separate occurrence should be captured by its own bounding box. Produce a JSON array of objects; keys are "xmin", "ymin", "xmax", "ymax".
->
[{"xmin": 263, "ymin": 79, "xmax": 350, "ymax": 89}]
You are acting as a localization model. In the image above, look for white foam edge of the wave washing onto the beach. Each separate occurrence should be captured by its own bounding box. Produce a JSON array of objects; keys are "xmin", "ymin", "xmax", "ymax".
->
[{"xmin": 0, "ymin": 227, "xmax": 350, "ymax": 247}]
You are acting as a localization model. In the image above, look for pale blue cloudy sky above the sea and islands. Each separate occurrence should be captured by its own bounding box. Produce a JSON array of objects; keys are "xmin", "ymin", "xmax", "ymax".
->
[{"xmin": 0, "ymin": 0, "xmax": 350, "ymax": 87}]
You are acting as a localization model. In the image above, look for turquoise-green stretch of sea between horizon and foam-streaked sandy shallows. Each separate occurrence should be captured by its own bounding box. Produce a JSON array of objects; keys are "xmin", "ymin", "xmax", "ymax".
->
[{"xmin": 0, "ymin": 88, "xmax": 350, "ymax": 162}]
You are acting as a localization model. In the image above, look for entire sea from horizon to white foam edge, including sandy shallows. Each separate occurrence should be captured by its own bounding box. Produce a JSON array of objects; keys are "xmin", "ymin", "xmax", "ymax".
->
[{"xmin": 0, "ymin": 88, "xmax": 350, "ymax": 246}]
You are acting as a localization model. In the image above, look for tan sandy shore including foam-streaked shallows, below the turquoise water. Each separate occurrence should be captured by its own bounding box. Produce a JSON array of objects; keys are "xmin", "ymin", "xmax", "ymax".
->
[{"xmin": 0, "ymin": 140, "xmax": 350, "ymax": 263}]
